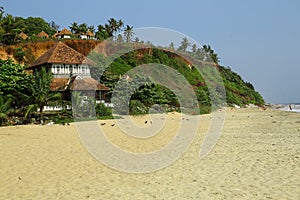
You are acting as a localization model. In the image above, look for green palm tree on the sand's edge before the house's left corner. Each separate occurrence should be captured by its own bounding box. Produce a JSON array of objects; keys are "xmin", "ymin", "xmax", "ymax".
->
[{"xmin": 26, "ymin": 67, "xmax": 61, "ymax": 124}]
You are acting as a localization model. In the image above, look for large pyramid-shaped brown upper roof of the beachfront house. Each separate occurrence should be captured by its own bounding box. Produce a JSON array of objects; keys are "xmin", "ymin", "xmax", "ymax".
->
[{"xmin": 29, "ymin": 42, "xmax": 96, "ymax": 68}]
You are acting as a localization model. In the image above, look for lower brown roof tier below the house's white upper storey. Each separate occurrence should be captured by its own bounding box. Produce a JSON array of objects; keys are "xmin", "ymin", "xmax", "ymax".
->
[{"xmin": 50, "ymin": 76, "xmax": 109, "ymax": 91}]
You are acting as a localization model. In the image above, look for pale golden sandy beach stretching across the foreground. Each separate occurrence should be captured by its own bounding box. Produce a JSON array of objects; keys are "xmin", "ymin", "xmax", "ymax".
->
[{"xmin": 0, "ymin": 108, "xmax": 300, "ymax": 199}]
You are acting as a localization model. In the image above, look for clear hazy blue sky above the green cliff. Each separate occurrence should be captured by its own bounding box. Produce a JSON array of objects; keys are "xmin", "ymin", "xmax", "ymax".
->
[{"xmin": 0, "ymin": 0, "xmax": 300, "ymax": 103}]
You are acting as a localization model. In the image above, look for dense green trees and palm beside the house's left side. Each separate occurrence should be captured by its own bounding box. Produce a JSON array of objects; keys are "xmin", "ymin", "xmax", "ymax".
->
[{"xmin": 0, "ymin": 60, "xmax": 61, "ymax": 125}]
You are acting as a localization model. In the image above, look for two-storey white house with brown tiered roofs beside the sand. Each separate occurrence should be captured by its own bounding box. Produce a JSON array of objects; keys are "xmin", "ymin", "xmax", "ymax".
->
[{"xmin": 28, "ymin": 42, "xmax": 109, "ymax": 108}]
